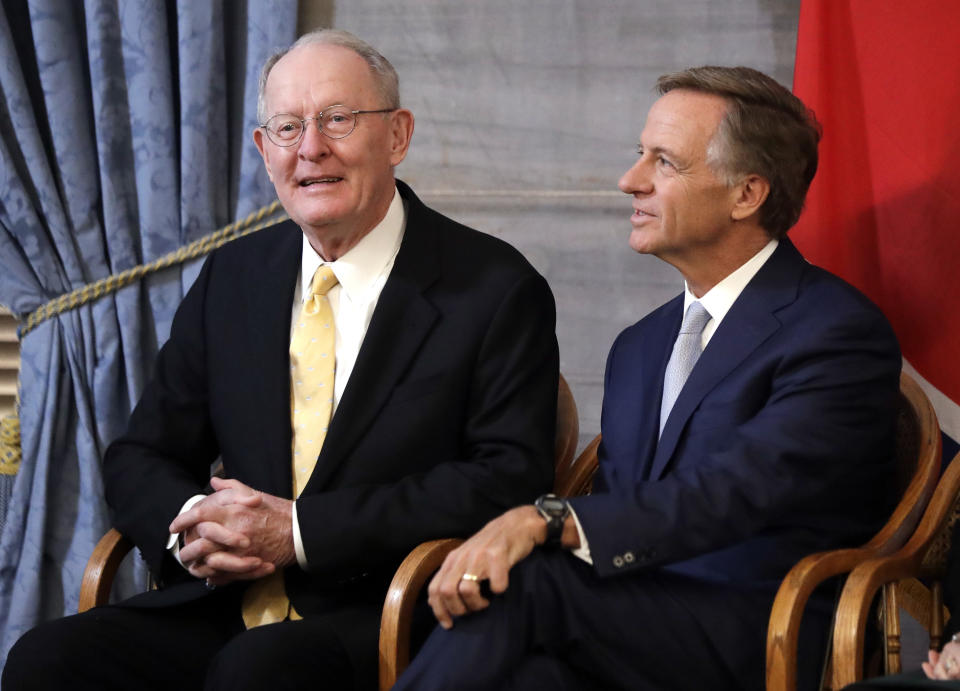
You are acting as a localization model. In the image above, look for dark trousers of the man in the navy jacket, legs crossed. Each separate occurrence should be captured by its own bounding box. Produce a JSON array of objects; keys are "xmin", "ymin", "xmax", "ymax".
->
[{"xmin": 394, "ymin": 550, "xmax": 772, "ymax": 691}]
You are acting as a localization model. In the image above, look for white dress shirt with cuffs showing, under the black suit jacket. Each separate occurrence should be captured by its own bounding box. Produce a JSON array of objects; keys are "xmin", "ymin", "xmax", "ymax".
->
[{"xmin": 167, "ymin": 188, "xmax": 407, "ymax": 569}]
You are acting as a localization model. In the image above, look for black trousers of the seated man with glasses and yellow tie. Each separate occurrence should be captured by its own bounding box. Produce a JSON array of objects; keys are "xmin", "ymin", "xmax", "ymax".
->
[{"xmin": 2, "ymin": 589, "xmax": 379, "ymax": 691}]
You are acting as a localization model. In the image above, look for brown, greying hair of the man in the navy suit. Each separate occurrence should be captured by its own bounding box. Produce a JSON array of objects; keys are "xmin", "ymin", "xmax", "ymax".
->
[{"xmin": 657, "ymin": 66, "xmax": 820, "ymax": 238}]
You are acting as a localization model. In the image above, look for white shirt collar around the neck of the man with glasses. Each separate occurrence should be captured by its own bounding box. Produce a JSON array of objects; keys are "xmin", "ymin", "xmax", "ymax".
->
[{"xmin": 300, "ymin": 188, "xmax": 407, "ymax": 300}]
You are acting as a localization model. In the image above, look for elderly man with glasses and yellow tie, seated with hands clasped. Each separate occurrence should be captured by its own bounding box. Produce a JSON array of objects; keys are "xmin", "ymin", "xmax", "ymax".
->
[{"xmin": 3, "ymin": 30, "xmax": 558, "ymax": 690}]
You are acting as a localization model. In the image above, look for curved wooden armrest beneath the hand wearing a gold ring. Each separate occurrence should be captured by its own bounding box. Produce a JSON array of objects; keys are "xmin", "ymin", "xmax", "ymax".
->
[{"xmin": 380, "ymin": 538, "xmax": 463, "ymax": 690}]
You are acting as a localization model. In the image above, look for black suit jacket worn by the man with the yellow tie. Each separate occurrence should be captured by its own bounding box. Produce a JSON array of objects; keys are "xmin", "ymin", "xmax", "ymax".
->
[{"xmin": 105, "ymin": 182, "xmax": 558, "ymax": 616}]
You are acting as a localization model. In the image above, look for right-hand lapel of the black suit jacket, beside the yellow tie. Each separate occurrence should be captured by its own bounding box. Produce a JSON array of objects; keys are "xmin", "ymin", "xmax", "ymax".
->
[{"xmin": 304, "ymin": 181, "xmax": 439, "ymax": 492}]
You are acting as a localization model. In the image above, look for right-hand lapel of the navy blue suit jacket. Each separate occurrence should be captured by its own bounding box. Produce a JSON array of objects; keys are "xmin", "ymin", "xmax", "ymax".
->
[{"xmin": 650, "ymin": 238, "xmax": 804, "ymax": 479}]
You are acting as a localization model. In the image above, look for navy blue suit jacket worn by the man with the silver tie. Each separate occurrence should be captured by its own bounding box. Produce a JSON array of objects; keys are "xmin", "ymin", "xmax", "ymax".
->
[{"xmin": 573, "ymin": 239, "xmax": 900, "ymax": 588}]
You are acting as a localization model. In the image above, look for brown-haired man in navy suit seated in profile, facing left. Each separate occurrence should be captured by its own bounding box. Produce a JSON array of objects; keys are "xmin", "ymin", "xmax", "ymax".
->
[{"xmin": 397, "ymin": 67, "xmax": 900, "ymax": 691}]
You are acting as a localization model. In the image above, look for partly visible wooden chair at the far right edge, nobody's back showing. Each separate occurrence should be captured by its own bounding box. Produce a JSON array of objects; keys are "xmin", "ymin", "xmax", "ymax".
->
[{"xmin": 832, "ymin": 454, "xmax": 960, "ymax": 689}]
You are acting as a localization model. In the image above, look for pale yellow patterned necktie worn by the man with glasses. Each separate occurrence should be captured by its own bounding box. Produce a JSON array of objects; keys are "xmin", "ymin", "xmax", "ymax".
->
[{"xmin": 243, "ymin": 266, "xmax": 337, "ymax": 629}]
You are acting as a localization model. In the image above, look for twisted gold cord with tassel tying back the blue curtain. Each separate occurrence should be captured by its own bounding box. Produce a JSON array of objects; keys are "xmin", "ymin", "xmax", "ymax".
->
[{"xmin": 0, "ymin": 201, "xmax": 289, "ymax": 475}]
